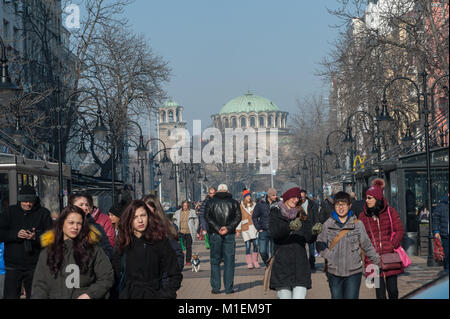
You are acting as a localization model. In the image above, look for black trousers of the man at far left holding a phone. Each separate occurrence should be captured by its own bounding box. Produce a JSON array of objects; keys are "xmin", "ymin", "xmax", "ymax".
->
[{"xmin": 3, "ymin": 268, "xmax": 34, "ymax": 299}]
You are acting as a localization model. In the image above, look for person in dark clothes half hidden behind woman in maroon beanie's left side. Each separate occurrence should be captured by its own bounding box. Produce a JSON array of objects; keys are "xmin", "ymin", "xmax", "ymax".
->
[{"xmin": 252, "ymin": 188, "xmax": 278, "ymax": 266}]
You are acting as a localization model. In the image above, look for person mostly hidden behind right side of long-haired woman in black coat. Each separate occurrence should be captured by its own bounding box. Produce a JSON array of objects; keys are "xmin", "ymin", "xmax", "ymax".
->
[{"xmin": 142, "ymin": 194, "xmax": 184, "ymax": 271}]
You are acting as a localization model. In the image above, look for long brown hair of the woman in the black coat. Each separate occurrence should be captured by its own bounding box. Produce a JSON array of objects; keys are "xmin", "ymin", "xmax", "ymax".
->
[{"xmin": 117, "ymin": 200, "xmax": 165, "ymax": 253}]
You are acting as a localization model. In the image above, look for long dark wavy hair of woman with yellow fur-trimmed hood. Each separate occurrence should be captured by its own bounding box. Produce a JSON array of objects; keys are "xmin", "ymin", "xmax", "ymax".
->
[{"xmin": 47, "ymin": 204, "xmax": 94, "ymax": 277}]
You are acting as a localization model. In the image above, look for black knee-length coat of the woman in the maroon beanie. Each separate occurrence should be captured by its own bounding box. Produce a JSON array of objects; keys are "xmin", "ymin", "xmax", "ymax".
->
[{"xmin": 269, "ymin": 203, "xmax": 317, "ymax": 290}]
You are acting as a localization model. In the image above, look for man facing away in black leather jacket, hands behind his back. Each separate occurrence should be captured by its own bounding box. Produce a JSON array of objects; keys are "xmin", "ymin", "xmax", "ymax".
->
[{"xmin": 205, "ymin": 184, "xmax": 242, "ymax": 294}]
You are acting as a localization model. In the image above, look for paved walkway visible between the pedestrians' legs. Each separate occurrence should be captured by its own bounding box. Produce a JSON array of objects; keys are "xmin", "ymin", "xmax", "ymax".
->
[{"xmin": 178, "ymin": 238, "xmax": 442, "ymax": 299}]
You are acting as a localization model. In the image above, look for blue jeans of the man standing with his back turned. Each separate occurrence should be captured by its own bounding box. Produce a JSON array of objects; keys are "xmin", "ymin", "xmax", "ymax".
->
[{"xmin": 208, "ymin": 233, "xmax": 236, "ymax": 293}]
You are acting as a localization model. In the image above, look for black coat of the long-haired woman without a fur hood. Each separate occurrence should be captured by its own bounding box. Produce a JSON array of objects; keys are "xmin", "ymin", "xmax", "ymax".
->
[{"xmin": 113, "ymin": 236, "xmax": 183, "ymax": 299}]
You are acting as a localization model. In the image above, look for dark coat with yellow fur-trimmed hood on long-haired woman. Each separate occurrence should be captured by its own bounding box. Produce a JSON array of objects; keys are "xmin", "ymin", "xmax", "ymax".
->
[{"xmin": 31, "ymin": 226, "xmax": 114, "ymax": 299}]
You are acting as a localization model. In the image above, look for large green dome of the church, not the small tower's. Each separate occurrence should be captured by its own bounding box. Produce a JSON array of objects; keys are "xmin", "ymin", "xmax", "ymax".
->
[{"xmin": 219, "ymin": 92, "xmax": 280, "ymax": 114}]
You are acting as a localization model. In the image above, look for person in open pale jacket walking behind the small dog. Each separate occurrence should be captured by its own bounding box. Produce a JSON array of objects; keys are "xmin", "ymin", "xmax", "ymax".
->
[{"xmin": 172, "ymin": 200, "xmax": 198, "ymax": 267}]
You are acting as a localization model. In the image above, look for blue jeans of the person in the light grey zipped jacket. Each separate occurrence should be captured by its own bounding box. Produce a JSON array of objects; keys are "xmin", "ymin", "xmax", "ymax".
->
[{"xmin": 327, "ymin": 272, "xmax": 362, "ymax": 299}]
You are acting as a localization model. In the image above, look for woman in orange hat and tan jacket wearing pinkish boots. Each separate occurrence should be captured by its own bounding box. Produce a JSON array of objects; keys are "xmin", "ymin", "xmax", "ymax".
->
[{"xmin": 236, "ymin": 190, "xmax": 260, "ymax": 269}]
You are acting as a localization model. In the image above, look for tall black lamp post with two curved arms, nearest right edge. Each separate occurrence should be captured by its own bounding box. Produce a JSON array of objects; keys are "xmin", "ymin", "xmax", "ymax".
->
[{"xmin": 382, "ymin": 69, "xmax": 449, "ymax": 266}]
